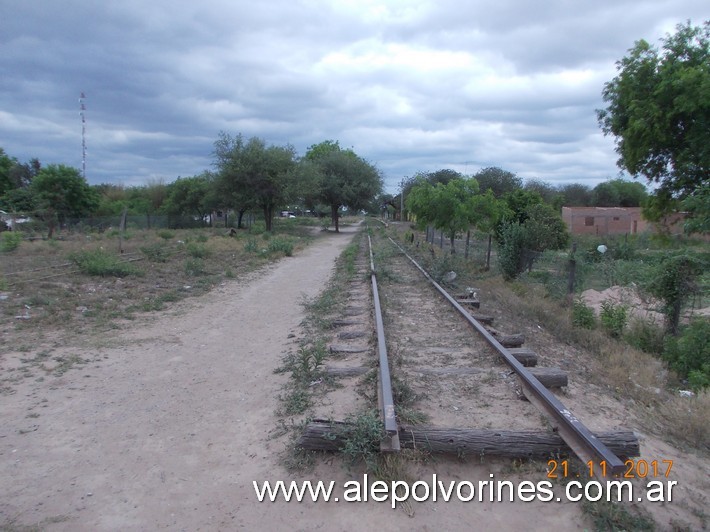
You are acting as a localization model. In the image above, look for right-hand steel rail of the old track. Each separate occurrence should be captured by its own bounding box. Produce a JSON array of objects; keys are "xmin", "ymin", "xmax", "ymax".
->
[{"xmin": 388, "ymin": 237, "xmax": 626, "ymax": 475}]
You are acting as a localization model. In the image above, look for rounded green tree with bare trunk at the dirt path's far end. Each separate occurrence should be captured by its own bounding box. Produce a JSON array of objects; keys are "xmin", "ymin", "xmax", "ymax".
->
[{"xmin": 306, "ymin": 141, "xmax": 382, "ymax": 232}]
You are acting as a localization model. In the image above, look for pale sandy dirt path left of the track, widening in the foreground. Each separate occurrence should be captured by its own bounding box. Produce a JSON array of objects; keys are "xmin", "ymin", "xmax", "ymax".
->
[{"xmin": 0, "ymin": 227, "xmax": 708, "ymax": 531}]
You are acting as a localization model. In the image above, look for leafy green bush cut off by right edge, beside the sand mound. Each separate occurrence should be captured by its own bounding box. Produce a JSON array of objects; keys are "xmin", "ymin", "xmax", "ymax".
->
[{"xmin": 663, "ymin": 319, "xmax": 710, "ymax": 389}]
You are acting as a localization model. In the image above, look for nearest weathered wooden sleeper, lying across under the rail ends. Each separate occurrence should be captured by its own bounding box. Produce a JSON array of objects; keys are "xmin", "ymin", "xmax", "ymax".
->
[{"xmin": 298, "ymin": 420, "xmax": 640, "ymax": 460}]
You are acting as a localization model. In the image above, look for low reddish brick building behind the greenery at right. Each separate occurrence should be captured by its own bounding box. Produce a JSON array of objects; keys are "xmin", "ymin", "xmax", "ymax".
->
[{"xmin": 562, "ymin": 207, "xmax": 685, "ymax": 236}]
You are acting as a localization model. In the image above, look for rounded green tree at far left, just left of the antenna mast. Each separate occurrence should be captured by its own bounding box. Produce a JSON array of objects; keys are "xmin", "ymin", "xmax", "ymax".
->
[{"xmin": 30, "ymin": 164, "xmax": 99, "ymax": 238}]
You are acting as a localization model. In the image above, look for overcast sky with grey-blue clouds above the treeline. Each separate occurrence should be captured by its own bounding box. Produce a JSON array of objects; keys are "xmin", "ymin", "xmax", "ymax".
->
[{"xmin": 0, "ymin": 0, "xmax": 710, "ymax": 193}]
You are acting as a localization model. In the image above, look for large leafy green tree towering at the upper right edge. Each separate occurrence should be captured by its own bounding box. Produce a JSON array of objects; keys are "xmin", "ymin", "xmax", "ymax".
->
[{"xmin": 597, "ymin": 21, "xmax": 710, "ymax": 213}]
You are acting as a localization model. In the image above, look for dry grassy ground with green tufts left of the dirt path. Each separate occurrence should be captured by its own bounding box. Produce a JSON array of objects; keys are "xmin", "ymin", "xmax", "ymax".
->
[{"xmin": 0, "ymin": 227, "xmax": 310, "ymax": 356}]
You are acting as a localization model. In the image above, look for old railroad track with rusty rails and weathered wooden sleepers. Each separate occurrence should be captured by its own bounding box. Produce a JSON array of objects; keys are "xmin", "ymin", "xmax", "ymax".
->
[{"xmin": 299, "ymin": 225, "xmax": 639, "ymax": 474}]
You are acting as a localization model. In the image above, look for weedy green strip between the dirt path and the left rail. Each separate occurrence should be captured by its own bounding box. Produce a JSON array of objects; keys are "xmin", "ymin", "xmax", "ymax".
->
[{"xmin": 277, "ymin": 227, "xmax": 422, "ymax": 492}]
